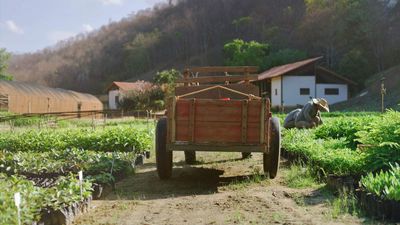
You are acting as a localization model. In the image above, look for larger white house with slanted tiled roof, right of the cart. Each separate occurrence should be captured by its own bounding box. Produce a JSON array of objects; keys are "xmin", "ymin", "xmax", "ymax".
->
[{"xmin": 256, "ymin": 57, "xmax": 357, "ymax": 108}]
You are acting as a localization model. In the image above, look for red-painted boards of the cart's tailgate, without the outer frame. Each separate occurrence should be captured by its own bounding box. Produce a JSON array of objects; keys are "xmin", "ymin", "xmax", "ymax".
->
[{"xmin": 175, "ymin": 99, "xmax": 265, "ymax": 144}]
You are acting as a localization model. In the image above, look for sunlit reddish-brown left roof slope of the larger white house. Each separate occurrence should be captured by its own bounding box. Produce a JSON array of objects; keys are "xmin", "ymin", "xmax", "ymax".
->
[{"xmin": 258, "ymin": 56, "xmax": 322, "ymax": 80}]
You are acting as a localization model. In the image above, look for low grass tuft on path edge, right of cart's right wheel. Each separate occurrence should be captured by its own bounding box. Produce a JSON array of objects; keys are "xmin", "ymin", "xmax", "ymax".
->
[{"xmin": 283, "ymin": 163, "xmax": 320, "ymax": 188}]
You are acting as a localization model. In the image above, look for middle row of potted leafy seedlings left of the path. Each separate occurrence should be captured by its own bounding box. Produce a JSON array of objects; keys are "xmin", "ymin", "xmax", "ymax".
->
[{"xmin": 0, "ymin": 148, "xmax": 135, "ymax": 184}]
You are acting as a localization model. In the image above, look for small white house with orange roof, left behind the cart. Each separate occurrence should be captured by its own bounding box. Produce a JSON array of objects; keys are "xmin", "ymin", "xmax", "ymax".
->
[{"xmin": 107, "ymin": 80, "xmax": 153, "ymax": 109}]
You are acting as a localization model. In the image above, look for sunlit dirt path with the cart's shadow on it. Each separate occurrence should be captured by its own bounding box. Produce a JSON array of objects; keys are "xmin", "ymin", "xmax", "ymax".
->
[{"xmin": 74, "ymin": 153, "xmax": 362, "ymax": 225}]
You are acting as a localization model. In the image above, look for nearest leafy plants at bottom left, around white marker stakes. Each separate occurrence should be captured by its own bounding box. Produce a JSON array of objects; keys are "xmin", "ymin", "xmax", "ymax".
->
[{"xmin": 0, "ymin": 173, "xmax": 92, "ymax": 224}]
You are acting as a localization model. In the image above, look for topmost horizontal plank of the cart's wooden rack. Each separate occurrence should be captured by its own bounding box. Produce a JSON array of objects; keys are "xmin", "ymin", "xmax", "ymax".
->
[{"xmin": 185, "ymin": 66, "xmax": 258, "ymax": 73}]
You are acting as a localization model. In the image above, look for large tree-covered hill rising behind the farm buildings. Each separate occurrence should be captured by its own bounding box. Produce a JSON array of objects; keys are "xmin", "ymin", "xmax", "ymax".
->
[{"xmin": 9, "ymin": 0, "xmax": 400, "ymax": 93}]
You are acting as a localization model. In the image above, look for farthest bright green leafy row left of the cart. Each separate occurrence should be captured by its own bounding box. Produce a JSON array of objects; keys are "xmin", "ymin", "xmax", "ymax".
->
[{"xmin": 0, "ymin": 126, "xmax": 152, "ymax": 152}]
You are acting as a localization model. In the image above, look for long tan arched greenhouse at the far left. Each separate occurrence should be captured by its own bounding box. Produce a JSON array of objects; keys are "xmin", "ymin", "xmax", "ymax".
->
[{"xmin": 0, "ymin": 81, "xmax": 103, "ymax": 114}]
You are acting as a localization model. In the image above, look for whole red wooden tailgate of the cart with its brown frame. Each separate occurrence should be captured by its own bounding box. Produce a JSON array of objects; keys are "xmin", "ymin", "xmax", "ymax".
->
[{"xmin": 167, "ymin": 97, "xmax": 271, "ymax": 153}]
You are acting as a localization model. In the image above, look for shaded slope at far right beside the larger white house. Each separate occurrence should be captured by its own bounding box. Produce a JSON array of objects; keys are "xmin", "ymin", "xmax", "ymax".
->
[{"xmin": 332, "ymin": 65, "xmax": 400, "ymax": 111}]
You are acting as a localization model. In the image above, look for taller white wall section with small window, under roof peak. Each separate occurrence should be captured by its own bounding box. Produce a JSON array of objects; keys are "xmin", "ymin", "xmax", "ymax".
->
[{"xmin": 282, "ymin": 76, "xmax": 315, "ymax": 106}]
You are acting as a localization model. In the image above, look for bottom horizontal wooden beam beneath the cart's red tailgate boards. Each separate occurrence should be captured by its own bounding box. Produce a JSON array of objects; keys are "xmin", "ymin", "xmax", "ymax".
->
[{"xmin": 167, "ymin": 142, "xmax": 266, "ymax": 152}]
